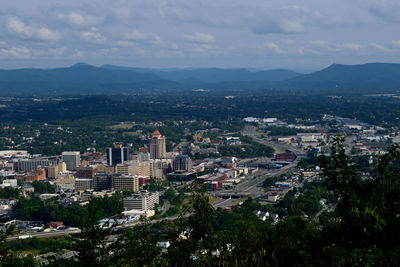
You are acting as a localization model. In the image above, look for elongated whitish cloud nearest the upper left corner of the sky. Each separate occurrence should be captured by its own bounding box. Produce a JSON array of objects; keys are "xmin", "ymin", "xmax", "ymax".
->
[{"xmin": 7, "ymin": 17, "xmax": 60, "ymax": 41}]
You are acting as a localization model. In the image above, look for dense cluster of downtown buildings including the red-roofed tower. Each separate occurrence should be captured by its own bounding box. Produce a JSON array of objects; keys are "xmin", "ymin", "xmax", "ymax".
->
[{"xmin": 0, "ymin": 130, "xmax": 192, "ymax": 216}]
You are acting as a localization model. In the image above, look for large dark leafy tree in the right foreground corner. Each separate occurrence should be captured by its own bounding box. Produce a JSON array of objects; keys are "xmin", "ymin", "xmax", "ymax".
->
[{"xmin": 319, "ymin": 137, "xmax": 400, "ymax": 266}]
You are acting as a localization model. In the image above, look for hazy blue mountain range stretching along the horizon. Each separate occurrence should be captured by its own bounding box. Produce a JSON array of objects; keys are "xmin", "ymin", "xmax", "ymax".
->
[{"xmin": 0, "ymin": 63, "xmax": 400, "ymax": 95}]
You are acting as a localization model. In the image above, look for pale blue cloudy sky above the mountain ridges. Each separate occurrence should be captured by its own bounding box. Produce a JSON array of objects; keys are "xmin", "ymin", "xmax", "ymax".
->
[{"xmin": 0, "ymin": 0, "xmax": 400, "ymax": 71}]
